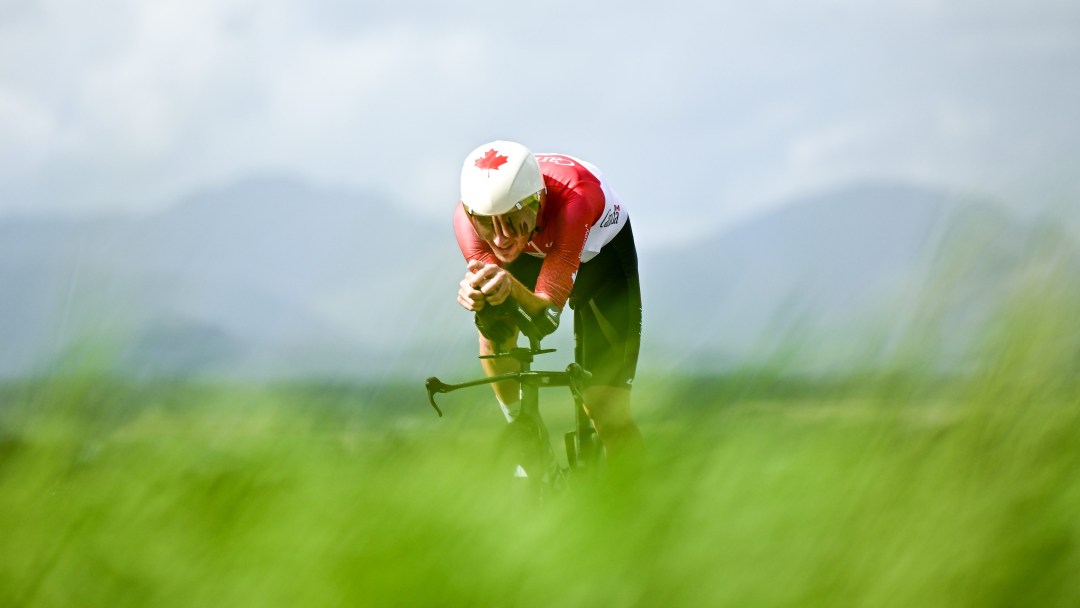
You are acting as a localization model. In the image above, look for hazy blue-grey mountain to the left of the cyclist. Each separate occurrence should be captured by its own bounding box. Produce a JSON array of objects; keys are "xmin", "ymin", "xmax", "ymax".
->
[{"xmin": 0, "ymin": 173, "xmax": 469, "ymax": 376}]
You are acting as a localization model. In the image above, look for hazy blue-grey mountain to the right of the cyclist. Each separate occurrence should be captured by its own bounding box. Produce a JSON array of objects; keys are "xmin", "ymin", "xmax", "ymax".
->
[{"xmin": 643, "ymin": 183, "xmax": 1080, "ymax": 369}]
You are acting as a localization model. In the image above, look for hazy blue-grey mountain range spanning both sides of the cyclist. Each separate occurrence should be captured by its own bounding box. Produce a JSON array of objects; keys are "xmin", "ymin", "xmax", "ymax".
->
[{"xmin": 0, "ymin": 178, "xmax": 1080, "ymax": 377}]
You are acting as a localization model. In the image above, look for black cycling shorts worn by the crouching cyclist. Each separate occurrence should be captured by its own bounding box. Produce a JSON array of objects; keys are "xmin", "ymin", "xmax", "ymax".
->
[{"xmin": 507, "ymin": 219, "xmax": 642, "ymax": 389}]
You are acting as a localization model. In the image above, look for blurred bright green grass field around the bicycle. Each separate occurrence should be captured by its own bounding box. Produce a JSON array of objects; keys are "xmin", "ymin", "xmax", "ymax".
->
[{"xmin": 0, "ymin": 307, "xmax": 1080, "ymax": 607}]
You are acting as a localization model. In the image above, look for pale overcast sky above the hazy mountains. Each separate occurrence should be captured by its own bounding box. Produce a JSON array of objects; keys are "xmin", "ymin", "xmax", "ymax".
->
[{"xmin": 0, "ymin": 0, "xmax": 1080, "ymax": 242}]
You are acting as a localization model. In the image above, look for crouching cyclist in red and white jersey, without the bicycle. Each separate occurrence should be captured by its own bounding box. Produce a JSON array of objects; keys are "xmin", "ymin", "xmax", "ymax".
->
[{"xmin": 454, "ymin": 140, "xmax": 642, "ymax": 461}]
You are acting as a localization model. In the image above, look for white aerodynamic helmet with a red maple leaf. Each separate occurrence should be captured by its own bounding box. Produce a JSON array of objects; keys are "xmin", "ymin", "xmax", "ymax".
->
[{"xmin": 461, "ymin": 140, "xmax": 544, "ymax": 215}]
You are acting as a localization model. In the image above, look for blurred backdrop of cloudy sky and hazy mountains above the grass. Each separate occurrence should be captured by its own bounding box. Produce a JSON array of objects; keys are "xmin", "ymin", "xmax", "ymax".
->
[{"xmin": 0, "ymin": 0, "xmax": 1080, "ymax": 379}]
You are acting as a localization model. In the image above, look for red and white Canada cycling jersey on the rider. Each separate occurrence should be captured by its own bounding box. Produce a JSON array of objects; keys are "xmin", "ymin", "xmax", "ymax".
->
[{"xmin": 454, "ymin": 154, "xmax": 627, "ymax": 307}]
